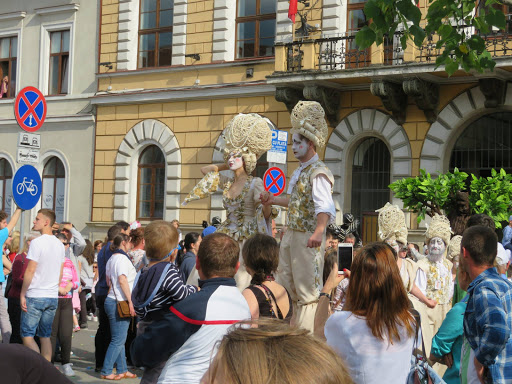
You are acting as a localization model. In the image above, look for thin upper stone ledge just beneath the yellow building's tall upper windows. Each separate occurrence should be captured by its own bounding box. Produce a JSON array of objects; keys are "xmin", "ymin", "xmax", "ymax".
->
[{"xmin": 96, "ymin": 58, "xmax": 275, "ymax": 79}]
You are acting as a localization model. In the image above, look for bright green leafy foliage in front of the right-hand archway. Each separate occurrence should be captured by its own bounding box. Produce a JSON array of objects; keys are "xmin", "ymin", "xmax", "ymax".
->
[{"xmin": 389, "ymin": 168, "xmax": 512, "ymax": 228}]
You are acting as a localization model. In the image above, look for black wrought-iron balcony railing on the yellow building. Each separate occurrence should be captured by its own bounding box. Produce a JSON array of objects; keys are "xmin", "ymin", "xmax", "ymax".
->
[{"xmin": 276, "ymin": 25, "xmax": 512, "ymax": 73}]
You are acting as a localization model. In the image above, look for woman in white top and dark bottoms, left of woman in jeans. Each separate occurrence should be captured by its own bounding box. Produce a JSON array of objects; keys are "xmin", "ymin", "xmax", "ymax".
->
[{"xmin": 78, "ymin": 239, "xmax": 96, "ymax": 328}]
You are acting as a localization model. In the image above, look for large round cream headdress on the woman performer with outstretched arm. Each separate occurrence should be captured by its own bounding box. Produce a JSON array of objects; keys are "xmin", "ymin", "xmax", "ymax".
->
[{"xmin": 223, "ymin": 113, "xmax": 272, "ymax": 174}]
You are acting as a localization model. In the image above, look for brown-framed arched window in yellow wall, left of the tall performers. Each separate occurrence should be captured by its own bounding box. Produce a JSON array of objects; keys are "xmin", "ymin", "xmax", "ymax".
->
[{"xmin": 137, "ymin": 145, "xmax": 165, "ymax": 219}]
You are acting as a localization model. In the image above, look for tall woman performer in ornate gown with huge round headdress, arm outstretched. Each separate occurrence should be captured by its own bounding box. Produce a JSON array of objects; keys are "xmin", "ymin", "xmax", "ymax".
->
[{"xmin": 183, "ymin": 113, "xmax": 275, "ymax": 290}]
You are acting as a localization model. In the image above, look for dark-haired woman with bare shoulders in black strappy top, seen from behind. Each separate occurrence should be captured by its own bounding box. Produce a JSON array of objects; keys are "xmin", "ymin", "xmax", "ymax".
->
[{"xmin": 242, "ymin": 233, "xmax": 293, "ymax": 323}]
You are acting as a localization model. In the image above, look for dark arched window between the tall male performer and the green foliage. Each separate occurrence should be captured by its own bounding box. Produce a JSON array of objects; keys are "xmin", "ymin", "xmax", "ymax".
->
[{"xmin": 350, "ymin": 137, "xmax": 391, "ymax": 241}]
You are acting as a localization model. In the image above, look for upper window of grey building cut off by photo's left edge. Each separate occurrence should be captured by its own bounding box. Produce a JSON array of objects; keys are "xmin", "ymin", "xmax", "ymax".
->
[{"xmin": 0, "ymin": 36, "xmax": 18, "ymax": 99}]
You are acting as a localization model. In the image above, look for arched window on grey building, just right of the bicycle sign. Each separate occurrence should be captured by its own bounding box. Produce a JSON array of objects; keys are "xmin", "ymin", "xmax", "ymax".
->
[{"xmin": 42, "ymin": 156, "xmax": 66, "ymax": 223}]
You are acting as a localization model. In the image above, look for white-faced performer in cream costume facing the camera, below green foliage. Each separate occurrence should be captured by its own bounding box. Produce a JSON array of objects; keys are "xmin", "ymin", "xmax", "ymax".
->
[{"xmin": 416, "ymin": 215, "xmax": 453, "ymax": 356}]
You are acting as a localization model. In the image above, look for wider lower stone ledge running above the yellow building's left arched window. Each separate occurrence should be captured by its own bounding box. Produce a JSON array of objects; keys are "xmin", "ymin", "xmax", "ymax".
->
[{"xmin": 91, "ymin": 82, "xmax": 276, "ymax": 106}]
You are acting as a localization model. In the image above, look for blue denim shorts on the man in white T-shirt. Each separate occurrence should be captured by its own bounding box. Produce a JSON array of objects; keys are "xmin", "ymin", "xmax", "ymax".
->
[{"xmin": 20, "ymin": 297, "xmax": 59, "ymax": 337}]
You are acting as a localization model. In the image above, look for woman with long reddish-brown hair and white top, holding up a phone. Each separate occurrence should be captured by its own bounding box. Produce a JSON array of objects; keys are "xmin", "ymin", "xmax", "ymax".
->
[{"xmin": 319, "ymin": 243, "xmax": 416, "ymax": 384}]
